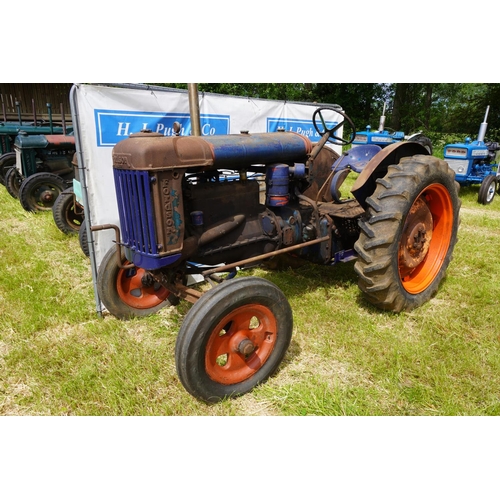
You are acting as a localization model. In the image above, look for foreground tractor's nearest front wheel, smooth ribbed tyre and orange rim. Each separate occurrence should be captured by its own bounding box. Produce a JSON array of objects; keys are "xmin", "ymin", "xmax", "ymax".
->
[{"xmin": 175, "ymin": 277, "xmax": 293, "ymax": 403}]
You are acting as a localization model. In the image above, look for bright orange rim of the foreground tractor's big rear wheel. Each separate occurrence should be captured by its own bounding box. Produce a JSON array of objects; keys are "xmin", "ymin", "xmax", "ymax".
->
[{"xmin": 398, "ymin": 184, "xmax": 454, "ymax": 294}]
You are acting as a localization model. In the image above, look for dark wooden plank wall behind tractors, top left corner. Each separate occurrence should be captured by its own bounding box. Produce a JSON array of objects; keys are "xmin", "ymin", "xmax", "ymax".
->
[{"xmin": 0, "ymin": 83, "xmax": 73, "ymax": 123}]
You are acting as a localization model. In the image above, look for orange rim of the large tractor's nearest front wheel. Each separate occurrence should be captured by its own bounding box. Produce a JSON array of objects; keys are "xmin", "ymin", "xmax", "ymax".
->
[{"xmin": 205, "ymin": 304, "xmax": 277, "ymax": 385}]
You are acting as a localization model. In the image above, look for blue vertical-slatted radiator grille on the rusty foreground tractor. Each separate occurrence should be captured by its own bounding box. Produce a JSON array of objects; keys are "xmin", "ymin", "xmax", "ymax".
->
[{"xmin": 114, "ymin": 169, "xmax": 158, "ymax": 255}]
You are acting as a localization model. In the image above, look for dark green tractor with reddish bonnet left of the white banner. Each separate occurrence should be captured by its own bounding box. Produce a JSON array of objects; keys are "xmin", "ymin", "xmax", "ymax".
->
[{"xmin": 5, "ymin": 131, "xmax": 75, "ymax": 212}]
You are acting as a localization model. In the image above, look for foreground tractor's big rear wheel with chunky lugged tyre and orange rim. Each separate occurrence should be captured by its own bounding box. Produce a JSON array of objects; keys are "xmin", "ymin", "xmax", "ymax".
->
[{"xmin": 354, "ymin": 155, "xmax": 461, "ymax": 312}]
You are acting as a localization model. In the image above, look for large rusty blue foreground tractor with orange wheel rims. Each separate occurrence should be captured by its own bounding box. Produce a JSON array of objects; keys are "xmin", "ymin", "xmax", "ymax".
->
[{"xmin": 91, "ymin": 106, "xmax": 460, "ymax": 402}]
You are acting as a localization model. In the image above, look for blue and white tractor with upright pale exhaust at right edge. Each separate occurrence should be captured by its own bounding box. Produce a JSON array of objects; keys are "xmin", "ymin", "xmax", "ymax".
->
[{"xmin": 443, "ymin": 106, "xmax": 500, "ymax": 205}]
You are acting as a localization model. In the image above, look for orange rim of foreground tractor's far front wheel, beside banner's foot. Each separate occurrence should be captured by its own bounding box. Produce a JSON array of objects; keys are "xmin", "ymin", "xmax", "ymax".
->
[{"xmin": 116, "ymin": 262, "xmax": 170, "ymax": 309}]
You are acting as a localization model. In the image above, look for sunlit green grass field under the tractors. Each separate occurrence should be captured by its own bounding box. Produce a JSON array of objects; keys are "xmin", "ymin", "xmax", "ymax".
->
[{"xmin": 0, "ymin": 181, "xmax": 500, "ymax": 415}]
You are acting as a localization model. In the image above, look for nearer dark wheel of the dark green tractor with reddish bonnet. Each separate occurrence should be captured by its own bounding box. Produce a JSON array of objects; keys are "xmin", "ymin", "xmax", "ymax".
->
[{"xmin": 19, "ymin": 172, "xmax": 66, "ymax": 212}]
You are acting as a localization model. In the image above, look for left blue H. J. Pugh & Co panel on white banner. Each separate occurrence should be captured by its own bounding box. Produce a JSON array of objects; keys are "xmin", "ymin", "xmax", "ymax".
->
[{"xmin": 94, "ymin": 109, "xmax": 230, "ymax": 147}]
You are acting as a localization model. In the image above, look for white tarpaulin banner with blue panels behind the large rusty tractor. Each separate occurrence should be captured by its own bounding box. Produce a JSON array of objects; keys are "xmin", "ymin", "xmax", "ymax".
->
[{"xmin": 70, "ymin": 84, "xmax": 341, "ymax": 311}]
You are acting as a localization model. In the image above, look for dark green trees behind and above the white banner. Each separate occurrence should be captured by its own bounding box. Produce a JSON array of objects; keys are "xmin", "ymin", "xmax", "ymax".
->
[{"xmin": 156, "ymin": 83, "xmax": 500, "ymax": 141}]
